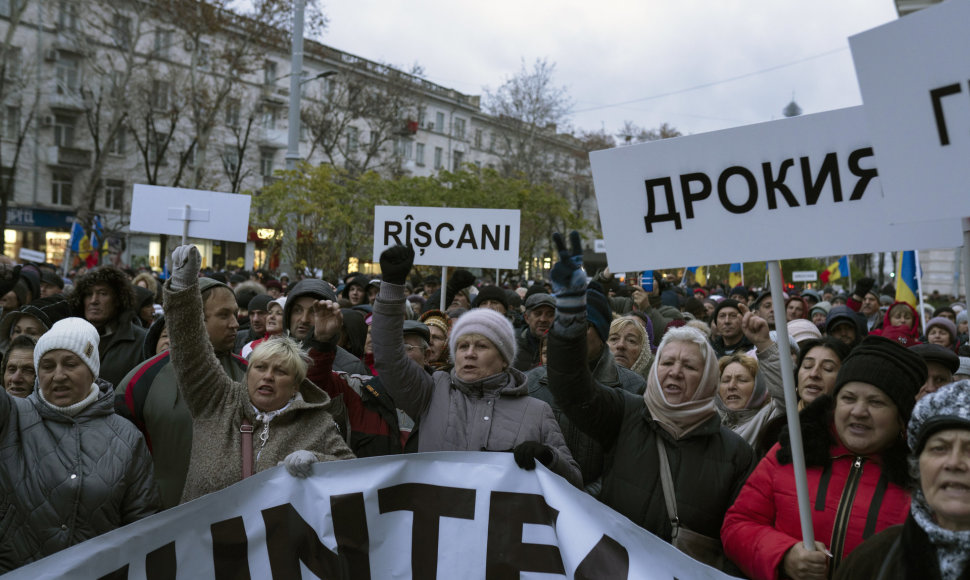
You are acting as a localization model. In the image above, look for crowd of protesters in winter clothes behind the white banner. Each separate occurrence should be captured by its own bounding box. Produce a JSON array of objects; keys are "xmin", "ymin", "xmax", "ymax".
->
[{"xmin": 0, "ymin": 234, "xmax": 970, "ymax": 580}]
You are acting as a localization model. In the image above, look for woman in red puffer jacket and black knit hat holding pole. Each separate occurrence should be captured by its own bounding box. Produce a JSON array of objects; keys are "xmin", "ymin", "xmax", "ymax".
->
[{"xmin": 721, "ymin": 336, "xmax": 926, "ymax": 580}]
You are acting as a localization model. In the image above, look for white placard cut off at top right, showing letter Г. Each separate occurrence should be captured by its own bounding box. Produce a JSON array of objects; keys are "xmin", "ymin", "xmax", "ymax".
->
[{"xmin": 849, "ymin": 0, "xmax": 970, "ymax": 223}]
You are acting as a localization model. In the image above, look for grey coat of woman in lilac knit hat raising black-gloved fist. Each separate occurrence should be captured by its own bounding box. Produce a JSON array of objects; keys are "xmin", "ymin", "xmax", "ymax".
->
[{"xmin": 371, "ymin": 282, "xmax": 582, "ymax": 487}]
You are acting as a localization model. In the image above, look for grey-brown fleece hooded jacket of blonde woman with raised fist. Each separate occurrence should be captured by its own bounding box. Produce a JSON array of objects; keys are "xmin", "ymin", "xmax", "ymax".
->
[{"xmin": 164, "ymin": 280, "xmax": 354, "ymax": 503}]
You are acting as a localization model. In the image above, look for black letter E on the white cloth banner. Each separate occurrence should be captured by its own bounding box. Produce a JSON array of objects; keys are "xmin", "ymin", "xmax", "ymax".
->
[{"xmin": 485, "ymin": 491, "xmax": 566, "ymax": 580}]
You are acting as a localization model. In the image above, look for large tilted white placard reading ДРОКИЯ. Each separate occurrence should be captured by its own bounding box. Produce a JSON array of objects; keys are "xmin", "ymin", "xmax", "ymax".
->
[{"xmin": 590, "ymin": 107, "xmax": 962, "ymax": 272}]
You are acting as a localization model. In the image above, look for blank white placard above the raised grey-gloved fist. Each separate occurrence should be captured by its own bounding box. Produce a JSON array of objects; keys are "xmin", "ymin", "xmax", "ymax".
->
[{"xmin": 130, "ymin": 184, "xmax": 252, "ymax": 243}]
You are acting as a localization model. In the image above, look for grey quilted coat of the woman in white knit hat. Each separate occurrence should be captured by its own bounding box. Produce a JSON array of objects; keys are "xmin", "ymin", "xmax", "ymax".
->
[{"xmin": 0, "ymin": 380, "xmax": 159, "ymax": 573}]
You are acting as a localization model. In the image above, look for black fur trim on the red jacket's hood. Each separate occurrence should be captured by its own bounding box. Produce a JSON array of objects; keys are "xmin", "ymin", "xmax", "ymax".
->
[{"xmin": 776, "ymin": 395, "xmax": 914, "ymax": 489}]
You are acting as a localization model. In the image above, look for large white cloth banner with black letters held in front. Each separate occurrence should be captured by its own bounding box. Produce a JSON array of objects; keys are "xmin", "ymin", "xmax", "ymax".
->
[{"xmin": 5, "ymin": 452, "xmax": 728, "ymax": 580}]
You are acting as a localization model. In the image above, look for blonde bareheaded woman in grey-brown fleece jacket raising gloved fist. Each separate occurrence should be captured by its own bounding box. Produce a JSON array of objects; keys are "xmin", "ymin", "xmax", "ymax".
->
[{"xmin": 164, "ymin": 246, "xmax": 353, "ymax": 503}]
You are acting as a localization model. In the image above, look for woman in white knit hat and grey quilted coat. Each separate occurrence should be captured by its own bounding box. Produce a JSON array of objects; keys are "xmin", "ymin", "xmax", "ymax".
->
[{"xmin": 0, "ymin": 318, "xmax": 159, "ymax": 573}]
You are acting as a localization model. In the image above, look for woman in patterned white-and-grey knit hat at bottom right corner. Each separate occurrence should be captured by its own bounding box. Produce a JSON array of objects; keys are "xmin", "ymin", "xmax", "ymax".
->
[{"xmin": 835, "ymin": 381, "xmax": 970, "ymax": 580}]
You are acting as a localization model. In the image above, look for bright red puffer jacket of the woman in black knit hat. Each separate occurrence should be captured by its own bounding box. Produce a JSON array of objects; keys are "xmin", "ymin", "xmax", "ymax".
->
[{"xmin": 721, "ymin": 397, "xmax": 910, "ymax": 579}]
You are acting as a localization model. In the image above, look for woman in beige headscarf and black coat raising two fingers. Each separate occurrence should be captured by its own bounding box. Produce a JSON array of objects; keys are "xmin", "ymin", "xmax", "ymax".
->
[{"xmin": 547, "ymin": 233, "xmax": 754, "ymax": 564}]
